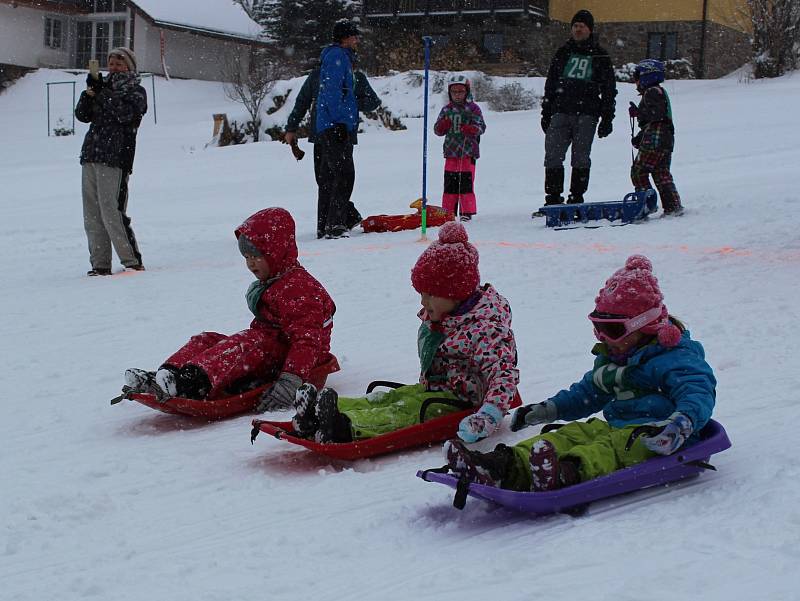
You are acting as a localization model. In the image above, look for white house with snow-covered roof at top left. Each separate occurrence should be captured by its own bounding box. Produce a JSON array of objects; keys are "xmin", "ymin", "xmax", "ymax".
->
[{"xmin": 0, "ymin": 0, "xmax": 264, "ymax": 80}]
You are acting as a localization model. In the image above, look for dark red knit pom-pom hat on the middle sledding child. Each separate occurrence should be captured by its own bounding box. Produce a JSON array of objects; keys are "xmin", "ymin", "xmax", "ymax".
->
[{"xmin": 411, "ymin": 221, "xmax": 481, "ymax": 301}]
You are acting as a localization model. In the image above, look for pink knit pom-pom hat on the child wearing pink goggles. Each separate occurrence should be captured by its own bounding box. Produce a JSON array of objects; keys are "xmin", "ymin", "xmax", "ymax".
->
[{"xmin": 594, "ymin": 255, "xmax": 681, "ymax": 347}]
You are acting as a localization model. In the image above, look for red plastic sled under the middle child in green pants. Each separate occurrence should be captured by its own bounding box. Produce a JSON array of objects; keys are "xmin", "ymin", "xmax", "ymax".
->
[{"xmin": 250, "ymin": 381, "xmax": 522, "ymax": 461}]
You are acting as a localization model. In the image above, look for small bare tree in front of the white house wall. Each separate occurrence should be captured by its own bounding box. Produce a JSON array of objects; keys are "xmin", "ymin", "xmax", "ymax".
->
[{"xmin": 222, "ymin": 52, "xmax": 284, "ymax": 142}]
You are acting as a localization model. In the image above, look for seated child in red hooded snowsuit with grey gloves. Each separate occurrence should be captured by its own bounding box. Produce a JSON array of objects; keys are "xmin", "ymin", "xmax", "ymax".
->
[{"xmin": 125, "ymin": 207, "xmax": 336, "ymax": 412}]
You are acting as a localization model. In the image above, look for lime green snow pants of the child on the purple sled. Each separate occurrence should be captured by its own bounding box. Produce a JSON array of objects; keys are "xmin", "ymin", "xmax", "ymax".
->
[{"xmin": 503, "ymin": 418, "xmax": 657, "ymax": 491}]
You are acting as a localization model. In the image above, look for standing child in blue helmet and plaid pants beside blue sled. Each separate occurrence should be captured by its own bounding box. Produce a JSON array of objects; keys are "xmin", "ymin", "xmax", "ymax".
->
[{"xmin": 628, "ymin": 59, "xmax": 683, "ymax": 216}]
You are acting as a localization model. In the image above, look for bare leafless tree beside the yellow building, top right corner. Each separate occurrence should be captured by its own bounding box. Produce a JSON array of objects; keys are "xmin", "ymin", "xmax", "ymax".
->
[{"xmin": 747, "ymin": 0, "xmax": 800, "ymax": 78}]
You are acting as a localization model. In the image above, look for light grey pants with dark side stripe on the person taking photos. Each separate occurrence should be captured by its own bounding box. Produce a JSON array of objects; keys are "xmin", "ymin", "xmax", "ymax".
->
[{"xmin": 81, "ymin": 163, "xmax": 142, "ymax": 269}]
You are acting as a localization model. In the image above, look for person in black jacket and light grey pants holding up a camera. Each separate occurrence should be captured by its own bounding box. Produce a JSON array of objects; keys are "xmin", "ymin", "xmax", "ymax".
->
[{"xmin": 75, "ymin": 47, "xmax": 147, "ymax": 276}]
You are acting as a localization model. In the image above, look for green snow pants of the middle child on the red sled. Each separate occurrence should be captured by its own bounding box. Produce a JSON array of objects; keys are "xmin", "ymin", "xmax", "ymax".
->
[{"xmin": 338, "ymin": 384, "xmax": 461, "ymax": 440}]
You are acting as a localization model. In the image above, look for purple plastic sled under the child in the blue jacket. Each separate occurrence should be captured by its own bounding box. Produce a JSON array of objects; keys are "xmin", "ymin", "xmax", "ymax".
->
[{"xmin": 417, "ymin": 419, "xmax": 731, "ymax": 515}]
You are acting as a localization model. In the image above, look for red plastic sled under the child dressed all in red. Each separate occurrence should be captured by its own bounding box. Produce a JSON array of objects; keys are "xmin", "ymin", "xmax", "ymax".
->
[{"xmin": 120, "ymin": 354, "xmax": 339, "ymax": 421}]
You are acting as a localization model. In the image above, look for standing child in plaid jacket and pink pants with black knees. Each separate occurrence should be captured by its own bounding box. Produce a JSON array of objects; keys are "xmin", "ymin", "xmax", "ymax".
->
[{"xmin": 433, "ymin": 75, "xmax": 486, "ymax": 221}]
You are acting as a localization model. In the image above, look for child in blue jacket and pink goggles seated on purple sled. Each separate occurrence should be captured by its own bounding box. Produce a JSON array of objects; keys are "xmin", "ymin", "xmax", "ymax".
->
[{"xmin": 444, "ymin": 255, "xmax": 716, "ymax": 491}]
